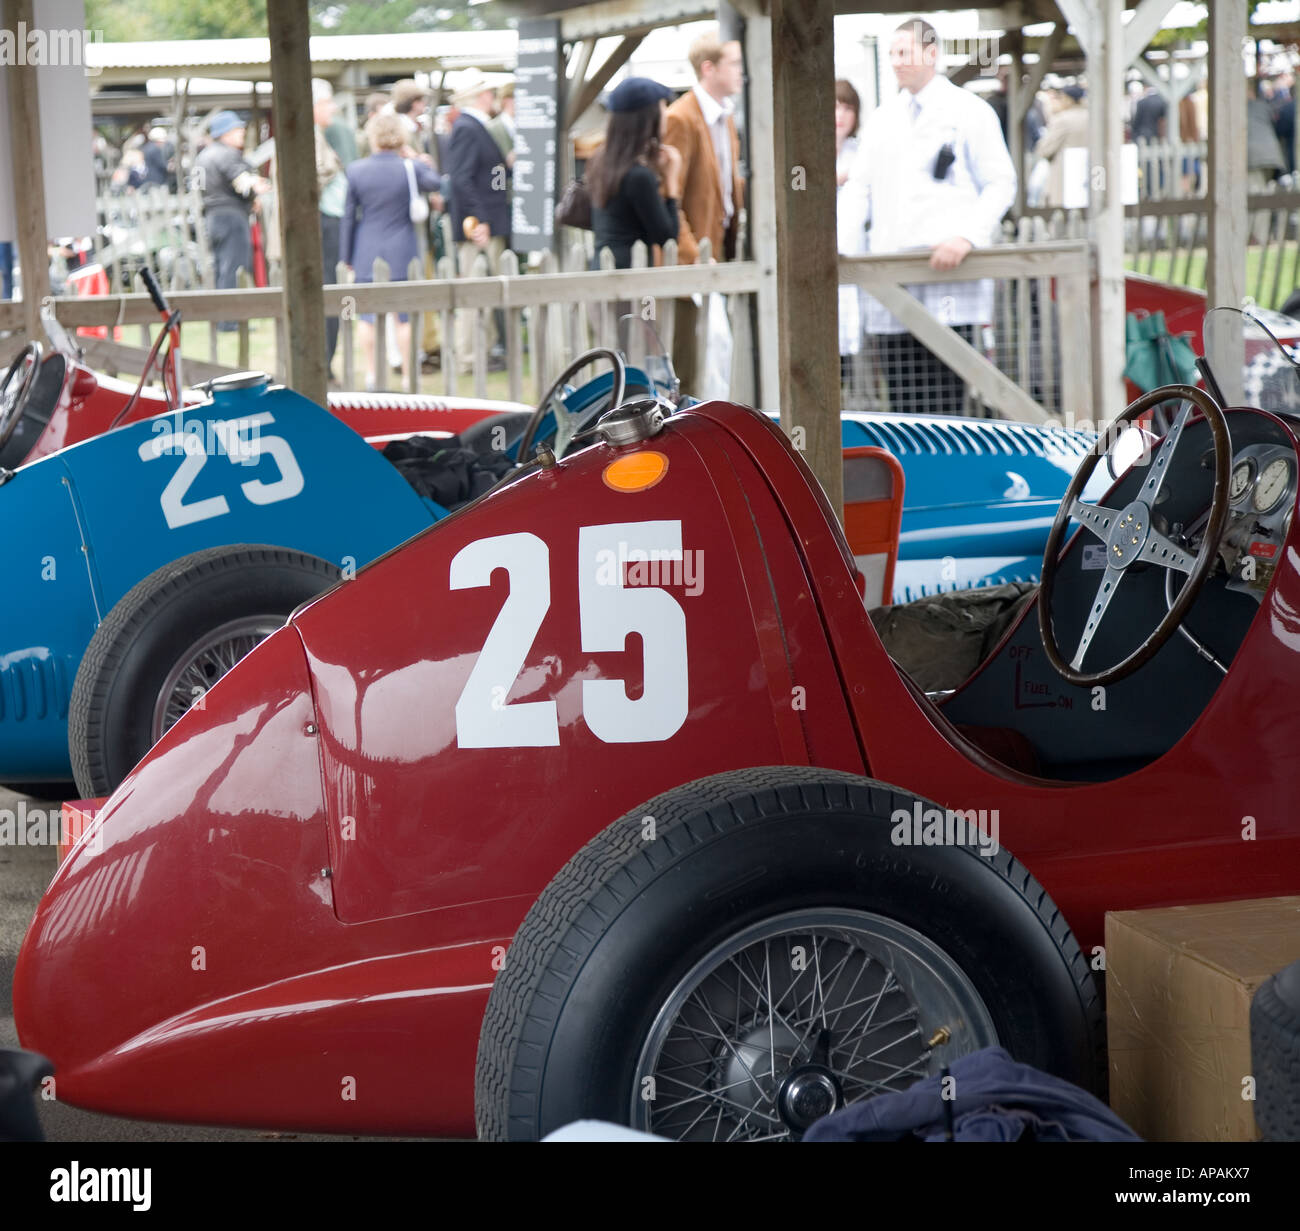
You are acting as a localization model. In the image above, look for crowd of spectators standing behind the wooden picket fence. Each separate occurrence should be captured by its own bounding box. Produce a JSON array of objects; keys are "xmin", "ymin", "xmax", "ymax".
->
[{"xmin": 30, "ymin": 18, "xmax": 1296, "ymax": 409}]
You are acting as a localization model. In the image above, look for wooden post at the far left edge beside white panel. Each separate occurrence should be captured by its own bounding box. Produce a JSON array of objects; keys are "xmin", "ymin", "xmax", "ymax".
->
[{"xmin": 5, "ymin": 0, "xmax": 49, "ymax": 342}]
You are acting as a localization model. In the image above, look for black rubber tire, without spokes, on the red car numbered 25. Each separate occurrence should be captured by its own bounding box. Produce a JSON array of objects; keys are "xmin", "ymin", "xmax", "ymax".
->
[{"xmin": 475, "ymin": 767, "xmax": 1105, "ymax": 1140}]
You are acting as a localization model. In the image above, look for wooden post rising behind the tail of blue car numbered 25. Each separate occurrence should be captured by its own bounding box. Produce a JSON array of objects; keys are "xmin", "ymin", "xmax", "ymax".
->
[{"xmin": 267, "ymin": 4, "xmax": 326, "ymax": 406}]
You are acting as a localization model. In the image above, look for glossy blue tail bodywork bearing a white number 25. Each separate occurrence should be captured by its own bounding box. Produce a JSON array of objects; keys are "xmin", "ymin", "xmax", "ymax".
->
[{"xmin": 0, "ymin": 386, "xmax": 436, "ymax": 781}]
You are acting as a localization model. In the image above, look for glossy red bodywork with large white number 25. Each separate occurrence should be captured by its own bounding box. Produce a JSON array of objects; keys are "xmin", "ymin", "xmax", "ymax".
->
[{"xmin": 14, "ymin": 403, "xmax": 1300, "ymax": 1135}]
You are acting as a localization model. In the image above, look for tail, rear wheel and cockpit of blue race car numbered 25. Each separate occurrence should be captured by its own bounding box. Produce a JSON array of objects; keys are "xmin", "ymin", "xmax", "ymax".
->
[{"xmin": 0, "ymin": 351, "xmax": 654, "ymax": 794}]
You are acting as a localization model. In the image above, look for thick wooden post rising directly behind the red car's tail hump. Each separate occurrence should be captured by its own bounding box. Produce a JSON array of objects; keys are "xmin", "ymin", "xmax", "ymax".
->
[{"xmin": 771, "ymin": 0, "xmax": 837, "ymax": 517}]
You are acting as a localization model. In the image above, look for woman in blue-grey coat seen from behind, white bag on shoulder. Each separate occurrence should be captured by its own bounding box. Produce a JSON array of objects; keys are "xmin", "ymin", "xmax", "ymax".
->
[{"xmin": 338, "ymin": 112, "xmax": 441, "ymax": 387}]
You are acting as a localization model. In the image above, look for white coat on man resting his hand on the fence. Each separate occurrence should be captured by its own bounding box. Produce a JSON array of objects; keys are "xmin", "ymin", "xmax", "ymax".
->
[{"xmin": 837, "ymin": 74, "xmax": 1015, "ymax": 333}]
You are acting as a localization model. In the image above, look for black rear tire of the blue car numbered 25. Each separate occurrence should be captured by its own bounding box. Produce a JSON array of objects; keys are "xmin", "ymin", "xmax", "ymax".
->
[{"xmin": 68, "ymin": 543, "xmax": 339, "ymax": 797}]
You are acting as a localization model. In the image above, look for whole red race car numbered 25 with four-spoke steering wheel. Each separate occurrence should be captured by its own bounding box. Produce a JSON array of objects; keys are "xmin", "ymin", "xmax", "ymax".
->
[{"xmin": 14, "ymin": 313, "xmax": 1300, "ymax": 1140}]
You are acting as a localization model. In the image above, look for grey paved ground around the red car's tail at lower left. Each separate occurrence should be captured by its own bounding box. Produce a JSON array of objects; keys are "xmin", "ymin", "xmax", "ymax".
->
[{"xmin": 0, "ymin": 788, "xmax": 400, "ymax": 1141}]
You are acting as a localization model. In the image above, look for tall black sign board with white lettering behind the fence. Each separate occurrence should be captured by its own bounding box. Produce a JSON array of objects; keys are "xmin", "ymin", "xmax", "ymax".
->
[{"xmin": 510, "ymin": 19, "xmax": 564, "ymax": 252}]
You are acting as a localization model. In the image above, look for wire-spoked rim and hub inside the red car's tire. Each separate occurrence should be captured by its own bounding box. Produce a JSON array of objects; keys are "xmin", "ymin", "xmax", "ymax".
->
[{"xmin": 632, "ymin": 909, "xmax": 997, "ymax": 1141}]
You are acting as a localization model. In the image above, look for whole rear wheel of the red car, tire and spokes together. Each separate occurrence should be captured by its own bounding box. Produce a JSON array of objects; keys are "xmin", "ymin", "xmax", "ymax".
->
[{"xmin": 475, "ymin": 766, "xmax": 1105, "ymax": 1141}]
